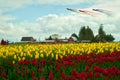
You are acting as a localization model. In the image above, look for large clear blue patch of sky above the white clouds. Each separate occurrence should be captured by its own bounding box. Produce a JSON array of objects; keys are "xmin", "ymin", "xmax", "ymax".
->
[{"xmin": 5, "ymin": 3, "xmax": 92, "ymax": 22}]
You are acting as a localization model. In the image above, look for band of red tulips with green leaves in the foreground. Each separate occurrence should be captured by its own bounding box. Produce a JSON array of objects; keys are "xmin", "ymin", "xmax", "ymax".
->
[{"xmin": 0, "ymin": 51, "xmax": 120, "ymax": 80}]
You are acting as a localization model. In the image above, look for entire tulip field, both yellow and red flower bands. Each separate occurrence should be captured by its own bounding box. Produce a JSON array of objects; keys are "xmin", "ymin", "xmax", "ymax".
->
[{"xmin": 0, "ymin": 42, "xmax": 120, "ymax": 80}]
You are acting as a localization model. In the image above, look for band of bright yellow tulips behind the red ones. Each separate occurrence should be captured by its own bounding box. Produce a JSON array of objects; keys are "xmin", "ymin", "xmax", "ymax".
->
[{"xmin": 0, "ymin": 43, "xmax": 120, "ymax": 61}]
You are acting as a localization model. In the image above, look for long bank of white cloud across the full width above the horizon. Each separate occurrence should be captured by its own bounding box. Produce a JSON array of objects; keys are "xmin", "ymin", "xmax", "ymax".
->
[{"xmin": 0, "ymin": 13, "xmax": 120, "ymax": 41}]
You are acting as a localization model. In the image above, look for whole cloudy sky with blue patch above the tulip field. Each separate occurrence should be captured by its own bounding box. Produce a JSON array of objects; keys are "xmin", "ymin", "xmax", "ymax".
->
[{"xmin": 0, "ymin": 0, "xmax": 120, "ymax": 42}]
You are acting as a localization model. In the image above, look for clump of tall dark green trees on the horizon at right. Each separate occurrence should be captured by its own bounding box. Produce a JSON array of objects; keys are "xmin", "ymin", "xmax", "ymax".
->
[{"xmin": 71, "ymin": 24, "xmax": 115, "ymax": 42}]
